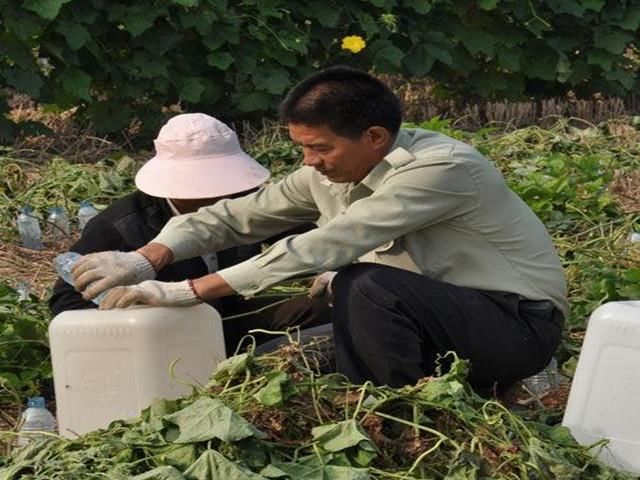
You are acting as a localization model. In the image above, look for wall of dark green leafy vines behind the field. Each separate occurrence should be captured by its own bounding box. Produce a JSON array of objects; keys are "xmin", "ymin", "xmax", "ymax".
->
[{"xmin": 0, "ymin": 0, "xmax": 640, "ymax": 138}]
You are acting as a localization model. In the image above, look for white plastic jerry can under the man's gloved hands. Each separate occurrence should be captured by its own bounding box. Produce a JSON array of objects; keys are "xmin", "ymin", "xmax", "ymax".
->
[{"xmin": 49, "ymin": 304, "xmax": 226, "ymax": 437}]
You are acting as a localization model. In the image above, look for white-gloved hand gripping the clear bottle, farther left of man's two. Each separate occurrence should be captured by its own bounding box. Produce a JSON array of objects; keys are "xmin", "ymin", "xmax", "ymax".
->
[{"xmin": 71, "ymin": 251, "xmax": 156, "ymax": 300}]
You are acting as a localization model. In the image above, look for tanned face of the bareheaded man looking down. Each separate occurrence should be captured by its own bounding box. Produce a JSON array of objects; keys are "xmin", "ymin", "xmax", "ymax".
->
[{"xmin": 289, "ymin": 123, "xmax": 388, "ymax": 183}]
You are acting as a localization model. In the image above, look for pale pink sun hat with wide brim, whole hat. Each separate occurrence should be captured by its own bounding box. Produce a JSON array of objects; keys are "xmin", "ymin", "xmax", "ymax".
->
[{"xmin": 136, "ymin": 113, "xmax": 269, "ymax": 199}]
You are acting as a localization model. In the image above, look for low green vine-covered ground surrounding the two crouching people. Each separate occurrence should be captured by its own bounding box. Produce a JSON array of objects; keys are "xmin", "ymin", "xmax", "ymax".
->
[{"xmin": 0, "ymin": 118, "xmax": 640, "ymax": 480}]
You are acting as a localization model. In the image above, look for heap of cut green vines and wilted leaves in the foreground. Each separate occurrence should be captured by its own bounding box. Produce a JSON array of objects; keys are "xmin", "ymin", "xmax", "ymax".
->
[{"xmin": 0, "ymin": 343, "xmax": 633, "ymax": 480}]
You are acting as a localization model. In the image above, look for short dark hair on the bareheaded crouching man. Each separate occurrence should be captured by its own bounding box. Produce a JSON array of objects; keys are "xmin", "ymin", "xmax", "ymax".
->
[{"xmin": 280, "ymin": 66, "xmax": 402, "ymax": 139}]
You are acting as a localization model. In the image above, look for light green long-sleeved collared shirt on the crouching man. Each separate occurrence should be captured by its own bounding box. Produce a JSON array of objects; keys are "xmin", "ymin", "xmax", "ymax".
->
[{"xmin": 153, "ymin": 129, "xmax": 569, "ymax": 316}]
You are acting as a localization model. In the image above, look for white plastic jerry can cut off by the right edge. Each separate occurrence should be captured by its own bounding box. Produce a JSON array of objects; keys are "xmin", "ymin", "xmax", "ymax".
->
[{"xmin": 562, "ymin": 301, "xmax": 640, "ymax": 473}]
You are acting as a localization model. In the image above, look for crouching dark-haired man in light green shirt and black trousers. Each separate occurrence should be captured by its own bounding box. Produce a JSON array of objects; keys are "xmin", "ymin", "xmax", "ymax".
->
[{"xmin": 74, "ymin": 67, "xmax": 568, "ymax": 388}]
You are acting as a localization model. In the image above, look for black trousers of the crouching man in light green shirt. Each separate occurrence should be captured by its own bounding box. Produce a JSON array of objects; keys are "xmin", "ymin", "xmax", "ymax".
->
[{"xmin": 332, "ymin": 263, "xmax": 563, "ymax": 388}]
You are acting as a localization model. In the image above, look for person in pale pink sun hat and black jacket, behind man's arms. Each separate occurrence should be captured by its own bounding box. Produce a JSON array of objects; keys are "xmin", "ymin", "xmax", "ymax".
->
[{"xmin": 49, "ymin": 113, "xmax": 330, "ymax": 350}]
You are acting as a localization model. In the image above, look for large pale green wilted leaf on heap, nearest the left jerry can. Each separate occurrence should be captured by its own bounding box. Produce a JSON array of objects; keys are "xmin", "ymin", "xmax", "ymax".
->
[{"xmin": 165, "ymin": 397, "xmax": 263, "ymax": 443}]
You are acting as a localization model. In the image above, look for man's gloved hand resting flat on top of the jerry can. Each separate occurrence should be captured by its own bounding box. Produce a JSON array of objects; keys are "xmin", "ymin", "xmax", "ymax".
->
[{"xmin": 100, "ymin": 280, "xmax": 201, "ymax": 310}]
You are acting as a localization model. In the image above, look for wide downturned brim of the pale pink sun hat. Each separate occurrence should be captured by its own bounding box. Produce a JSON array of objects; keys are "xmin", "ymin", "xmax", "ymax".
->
[{"xmin": 135, "ymin": 153, "xmax": 270, "ymax": 200}]
